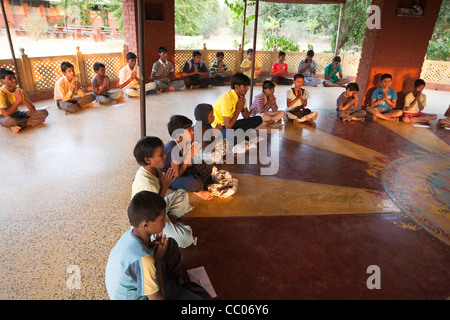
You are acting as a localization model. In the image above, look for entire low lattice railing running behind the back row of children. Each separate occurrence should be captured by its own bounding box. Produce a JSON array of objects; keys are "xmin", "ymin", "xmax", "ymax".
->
[{"xmin": 0, "ymin": 48, "xmax": 450, "ymax": 92}]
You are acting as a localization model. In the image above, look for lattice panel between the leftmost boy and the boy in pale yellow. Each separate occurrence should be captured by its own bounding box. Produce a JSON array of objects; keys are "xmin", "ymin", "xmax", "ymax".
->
[{"xmin": 30, "ymin": 56, "xmax": 76, "ymax": 91}]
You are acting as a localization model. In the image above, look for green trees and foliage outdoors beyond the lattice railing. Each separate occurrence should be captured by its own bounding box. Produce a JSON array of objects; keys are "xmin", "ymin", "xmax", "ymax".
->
[{"xmin": 43, "ymin": 0, "xmax": 450, "ymax": 61}]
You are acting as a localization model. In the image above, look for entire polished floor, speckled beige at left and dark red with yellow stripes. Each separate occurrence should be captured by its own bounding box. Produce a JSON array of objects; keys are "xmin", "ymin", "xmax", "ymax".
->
[{"xmin": 0, "ymin": 86, "xmax": 450, "ymax": 299}]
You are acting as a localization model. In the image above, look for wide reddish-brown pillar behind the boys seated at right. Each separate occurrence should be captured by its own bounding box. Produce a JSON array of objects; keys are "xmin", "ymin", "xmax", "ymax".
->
[{"xmin": 356, "ymin": 0, "xmax": 442, "ymax": 109}]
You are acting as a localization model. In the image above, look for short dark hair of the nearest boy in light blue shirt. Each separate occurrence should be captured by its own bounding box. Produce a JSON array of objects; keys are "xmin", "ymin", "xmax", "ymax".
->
[{"xmin": 128, "ymin": 190, "xmax": 166, "ymax": 228}]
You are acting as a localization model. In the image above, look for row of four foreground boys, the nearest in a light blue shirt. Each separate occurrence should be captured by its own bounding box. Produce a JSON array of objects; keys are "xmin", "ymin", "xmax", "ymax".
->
[{"xmin": 105, "ymin": 104, "xmax": 223, "ymax": 300}]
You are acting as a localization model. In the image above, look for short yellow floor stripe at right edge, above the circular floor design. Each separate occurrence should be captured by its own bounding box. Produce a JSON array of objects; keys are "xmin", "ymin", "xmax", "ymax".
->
[{"xmin": 376, "ymin": 119, "xmax": 450, "ymax": 152}]
